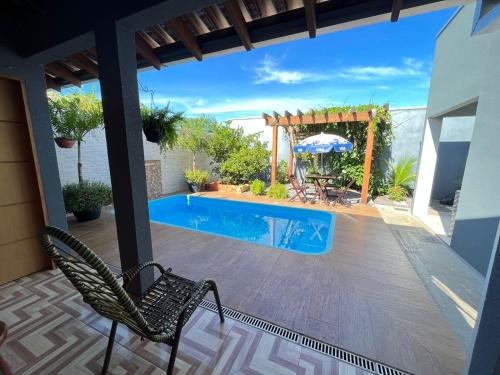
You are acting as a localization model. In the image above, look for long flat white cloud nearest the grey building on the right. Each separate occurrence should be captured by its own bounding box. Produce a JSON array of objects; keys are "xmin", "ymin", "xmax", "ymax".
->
[{"xmin": 338, "ymin": 57, "xmax": 428, "ymax": 81}]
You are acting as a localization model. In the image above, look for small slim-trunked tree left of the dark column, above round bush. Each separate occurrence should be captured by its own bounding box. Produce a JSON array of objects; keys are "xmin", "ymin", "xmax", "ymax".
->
[{"xmin": 49, "ymin": 93, "xmax": 103, "ymax": 183}]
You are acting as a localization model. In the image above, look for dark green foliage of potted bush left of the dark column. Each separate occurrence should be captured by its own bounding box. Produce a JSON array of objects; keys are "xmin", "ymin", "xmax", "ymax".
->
[{"xmin": 63, "ymin": 181, "xmax": 113, "ymax": 213}]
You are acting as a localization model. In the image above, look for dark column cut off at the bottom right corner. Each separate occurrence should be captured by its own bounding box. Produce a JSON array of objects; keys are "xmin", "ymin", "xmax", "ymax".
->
[{"xmin": 464, "ymin": 228, "xmax": 500, "ymax": 375}]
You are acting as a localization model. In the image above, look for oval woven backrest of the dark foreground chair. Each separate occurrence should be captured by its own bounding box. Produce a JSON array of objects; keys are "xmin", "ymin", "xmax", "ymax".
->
[{"xmin": 38, "ymin": 226, "xmax": 153, "ymax": 335}]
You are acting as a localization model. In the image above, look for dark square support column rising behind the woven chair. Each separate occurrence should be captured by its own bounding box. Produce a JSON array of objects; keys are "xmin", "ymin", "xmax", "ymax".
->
[{"xmin": 96, "ymin": 23, "xmax": 153, "ymax": 292}]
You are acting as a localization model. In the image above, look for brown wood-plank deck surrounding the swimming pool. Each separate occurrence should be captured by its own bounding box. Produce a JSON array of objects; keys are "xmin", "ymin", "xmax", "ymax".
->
[{"xmin": 70, "ymin": 198, "xmax": 464, "ymax": 375}]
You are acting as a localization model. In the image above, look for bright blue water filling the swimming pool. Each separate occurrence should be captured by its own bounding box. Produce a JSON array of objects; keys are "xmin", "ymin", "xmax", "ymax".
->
[{"xmin": 149, "ymin": 195, "xmax": 335, "ymax": 255}]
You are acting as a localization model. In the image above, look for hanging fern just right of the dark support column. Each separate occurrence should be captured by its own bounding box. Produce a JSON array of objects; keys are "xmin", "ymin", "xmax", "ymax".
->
[{"xmin": 141, "ymin": 104, "xmax": 184, "ymax": 151}]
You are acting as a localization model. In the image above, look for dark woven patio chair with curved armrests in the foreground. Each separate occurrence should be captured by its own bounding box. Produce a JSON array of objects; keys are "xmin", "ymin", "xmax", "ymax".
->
[{"xmin": 39, "ymin": 226, "xmax": 224, "ymax": 375}]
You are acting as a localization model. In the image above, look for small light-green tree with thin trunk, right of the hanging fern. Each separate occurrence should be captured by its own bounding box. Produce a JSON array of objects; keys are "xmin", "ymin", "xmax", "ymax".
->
[{"xmin": 177, "ymin": 116, "xmax": 215, "ymax": 170}]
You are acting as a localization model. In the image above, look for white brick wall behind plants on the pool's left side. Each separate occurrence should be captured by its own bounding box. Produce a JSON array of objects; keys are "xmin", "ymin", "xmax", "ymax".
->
[{"xmin": 56, "ymin": 129, "xmax": 210, "ymax": 194}]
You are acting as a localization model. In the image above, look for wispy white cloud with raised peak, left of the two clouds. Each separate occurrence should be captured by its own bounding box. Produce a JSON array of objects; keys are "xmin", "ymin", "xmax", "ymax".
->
[{"xmin": 253, "ymin": 55, "xmax": 327, "ymax": 85}]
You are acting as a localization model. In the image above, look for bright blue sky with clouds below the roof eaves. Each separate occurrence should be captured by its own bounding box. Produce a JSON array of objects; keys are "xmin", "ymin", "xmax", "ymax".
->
[{"xmin": 74, "ymin": 8, "xmax": 455, "ymax": 121}]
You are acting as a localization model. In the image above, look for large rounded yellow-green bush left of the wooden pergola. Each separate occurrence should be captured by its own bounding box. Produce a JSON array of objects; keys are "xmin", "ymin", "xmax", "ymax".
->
[{"xmin": 220, "ymin": 143, "xmax": 271, "ymax": 185}]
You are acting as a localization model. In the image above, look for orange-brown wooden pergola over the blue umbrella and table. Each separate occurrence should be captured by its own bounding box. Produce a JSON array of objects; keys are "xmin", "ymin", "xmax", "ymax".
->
[{"xmin": 262, "ymin": 110, "xmax": 382, "ymax": 204}]
